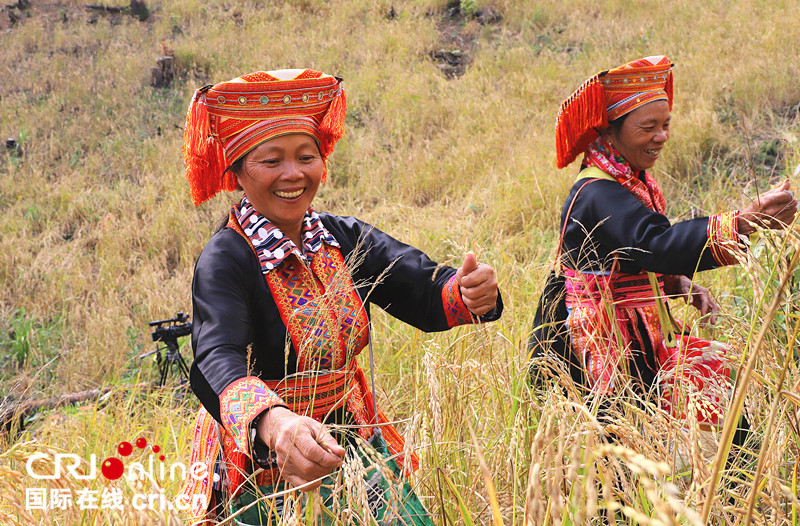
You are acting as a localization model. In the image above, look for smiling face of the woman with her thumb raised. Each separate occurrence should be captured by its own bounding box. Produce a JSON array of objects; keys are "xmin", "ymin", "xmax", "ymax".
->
[{"xmin": 236, "ymin": 133, "xmax": 324, "ymax": 234}]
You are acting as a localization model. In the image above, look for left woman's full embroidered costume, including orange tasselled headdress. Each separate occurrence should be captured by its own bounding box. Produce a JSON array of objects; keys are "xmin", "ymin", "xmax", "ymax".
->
[{"xmin": 183, "ymin": 70, "xmax": 502, "ymax": 525}]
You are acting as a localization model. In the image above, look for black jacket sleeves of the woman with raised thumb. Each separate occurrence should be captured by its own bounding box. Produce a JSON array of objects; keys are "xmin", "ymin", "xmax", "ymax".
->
[{"xmin": 191, "ymin": 213, "xmax": 502, "ymax": 421}]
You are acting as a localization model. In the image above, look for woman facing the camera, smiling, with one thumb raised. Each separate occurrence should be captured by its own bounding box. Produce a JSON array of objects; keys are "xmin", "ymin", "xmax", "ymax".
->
[{"xmin": 183, "ymin": 70, "xmax": 502, "ymax": 524}]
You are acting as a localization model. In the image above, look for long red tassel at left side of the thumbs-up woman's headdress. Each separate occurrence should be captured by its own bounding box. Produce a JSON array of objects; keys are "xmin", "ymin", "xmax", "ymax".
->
[{"xmin": 183, "ymin": 89, "xmax": 230, "ymax": 206}]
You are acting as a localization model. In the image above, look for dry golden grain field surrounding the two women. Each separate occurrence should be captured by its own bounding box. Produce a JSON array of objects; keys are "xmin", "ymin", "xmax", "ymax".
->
[{"xmin": 0, "ymin": 0, "xmax": 800, "ymax": 526}]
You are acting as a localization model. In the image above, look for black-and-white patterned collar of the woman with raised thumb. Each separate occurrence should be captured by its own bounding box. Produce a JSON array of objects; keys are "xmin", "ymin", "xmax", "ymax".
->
[{"xmin": 233, "ymin": 196, "xmax": 339, "ymax": 274}]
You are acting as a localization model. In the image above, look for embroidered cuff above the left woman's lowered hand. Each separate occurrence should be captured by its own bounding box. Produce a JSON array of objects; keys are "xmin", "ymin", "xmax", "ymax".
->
[{"xmin": 219, "ymin": 376, "xmax": 286, "ymax": 453}]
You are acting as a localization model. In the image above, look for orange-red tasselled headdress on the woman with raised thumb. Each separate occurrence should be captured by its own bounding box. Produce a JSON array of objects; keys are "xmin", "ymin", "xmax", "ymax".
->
[{"xmin": 183, "ymin": 69, "xmax": 347, "ymax": 206}]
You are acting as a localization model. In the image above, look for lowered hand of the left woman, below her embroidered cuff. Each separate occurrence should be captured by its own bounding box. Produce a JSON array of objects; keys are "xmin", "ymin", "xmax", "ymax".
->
[{"xmin": 256, "ymin": 407, "xmax": 345, "ymax": 491}]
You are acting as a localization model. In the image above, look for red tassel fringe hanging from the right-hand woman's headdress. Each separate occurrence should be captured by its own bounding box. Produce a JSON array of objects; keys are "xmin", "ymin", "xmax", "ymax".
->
[{"xmin": 556, "ymin": 75, "xmax": 608, "ymax": 168}]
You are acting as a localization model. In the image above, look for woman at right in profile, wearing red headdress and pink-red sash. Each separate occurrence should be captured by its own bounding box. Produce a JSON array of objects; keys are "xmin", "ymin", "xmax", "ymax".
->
[{"xmin": 530, "ymin": 56, "xmax": 797, "ymax": 434}]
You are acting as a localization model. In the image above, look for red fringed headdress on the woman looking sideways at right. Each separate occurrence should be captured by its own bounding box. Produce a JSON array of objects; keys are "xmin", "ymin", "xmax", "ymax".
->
[{"xmin": 556, "ymin": 55, "xmax": 672, "ymax": 168}]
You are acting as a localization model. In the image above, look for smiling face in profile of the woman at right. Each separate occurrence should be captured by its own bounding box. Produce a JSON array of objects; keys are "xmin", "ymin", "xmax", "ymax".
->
[{"xmin": 602, "ymin": 100, "xmax": 670, "ymax": 172}]
